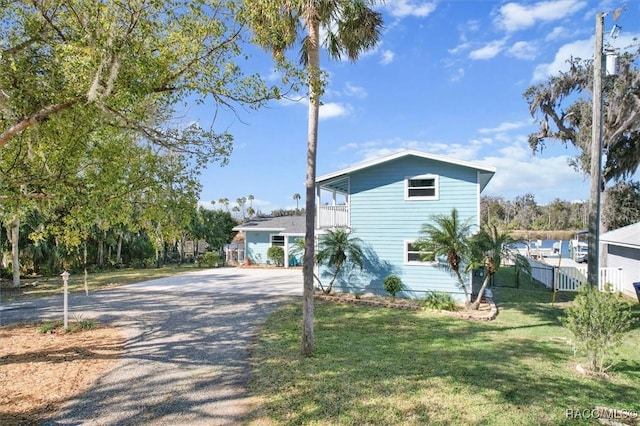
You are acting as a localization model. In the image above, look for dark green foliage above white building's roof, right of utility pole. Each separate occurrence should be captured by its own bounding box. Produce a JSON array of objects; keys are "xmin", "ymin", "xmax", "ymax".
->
[{"xmin": 602, "ymin": 181, "xmax": 640, "ymax": 230}]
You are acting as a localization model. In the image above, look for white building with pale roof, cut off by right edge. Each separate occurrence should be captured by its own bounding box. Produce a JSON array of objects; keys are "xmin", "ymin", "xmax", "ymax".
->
[{"xmin": 600, "ymin": 222, "xmax": 640, "ymax": 298}]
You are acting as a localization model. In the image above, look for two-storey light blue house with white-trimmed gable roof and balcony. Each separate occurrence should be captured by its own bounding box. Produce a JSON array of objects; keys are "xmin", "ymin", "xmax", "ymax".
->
[{"xmin": 316, "ymin": 151, "xmax": 495, "ymax": 300}]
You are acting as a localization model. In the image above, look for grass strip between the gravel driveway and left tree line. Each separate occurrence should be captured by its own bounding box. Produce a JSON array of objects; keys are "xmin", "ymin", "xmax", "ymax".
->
[{"xmin": 0, "ymin": 264, "xmax": 201, "ymax": 302}]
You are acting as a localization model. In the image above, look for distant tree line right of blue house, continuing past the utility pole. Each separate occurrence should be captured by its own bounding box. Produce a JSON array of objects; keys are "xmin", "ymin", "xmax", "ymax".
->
[{"xmin": 480, "ymin": 181, "xmax": 640, "ymax": 231}]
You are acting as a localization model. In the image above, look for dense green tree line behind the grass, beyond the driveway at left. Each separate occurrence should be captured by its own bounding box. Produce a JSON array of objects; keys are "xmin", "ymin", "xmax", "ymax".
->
[{"xmin": 0, "ymin": 207, "xmax": 238, "ymax": 284}]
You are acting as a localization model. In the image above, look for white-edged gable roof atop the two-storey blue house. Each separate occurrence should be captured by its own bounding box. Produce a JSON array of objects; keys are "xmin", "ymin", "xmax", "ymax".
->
[{"xmin": 316, "ymin": 149, "xmax": 496, "ymax": 191}]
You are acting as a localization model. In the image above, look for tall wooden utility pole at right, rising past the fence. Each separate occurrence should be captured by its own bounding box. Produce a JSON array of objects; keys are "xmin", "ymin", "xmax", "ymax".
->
[{"xmin": 587, "ymin": 12, "xmax": 605, "ymax": 287}]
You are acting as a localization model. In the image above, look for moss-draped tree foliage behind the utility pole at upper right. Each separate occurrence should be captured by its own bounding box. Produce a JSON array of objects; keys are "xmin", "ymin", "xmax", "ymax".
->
[{"xmin": 524, "ymin": 49, "xmax": 640, "ymax": 183}]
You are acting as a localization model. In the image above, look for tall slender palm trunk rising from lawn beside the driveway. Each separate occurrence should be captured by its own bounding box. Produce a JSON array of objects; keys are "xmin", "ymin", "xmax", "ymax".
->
[{"xmin": 302, "ymin": 19, "xmax": 320, "ymax": 355}]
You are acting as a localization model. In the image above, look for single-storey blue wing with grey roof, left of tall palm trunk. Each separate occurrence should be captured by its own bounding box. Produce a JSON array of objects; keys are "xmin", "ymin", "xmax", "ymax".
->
[{"xmin": 233, "ymin": 216, "xmax": 305, "ymax": 267}]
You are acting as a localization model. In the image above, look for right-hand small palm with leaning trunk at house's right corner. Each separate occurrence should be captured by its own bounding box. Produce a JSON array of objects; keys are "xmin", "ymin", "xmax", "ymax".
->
[{"xmin": 466, "ymin": 225, "xmax": 531, "ymax": 310}]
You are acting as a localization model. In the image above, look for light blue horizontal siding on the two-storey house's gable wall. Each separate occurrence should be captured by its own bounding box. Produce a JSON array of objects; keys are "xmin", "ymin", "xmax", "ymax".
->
[{"xmin": 320, "ymin": 156, "xmax": 479, "ymax": 300}]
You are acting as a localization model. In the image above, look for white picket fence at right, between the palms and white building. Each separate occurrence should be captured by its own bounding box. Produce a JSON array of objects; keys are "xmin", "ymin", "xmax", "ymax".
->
[{"xmin": 528, "ymin": 259, "xmax": 623, "ymax": 292}]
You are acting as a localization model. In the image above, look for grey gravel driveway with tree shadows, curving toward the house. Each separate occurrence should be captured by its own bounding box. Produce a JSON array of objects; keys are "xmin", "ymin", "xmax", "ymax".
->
[{"xmin": 0, "ymin": 268, "xmax": 302, "ymax": 425}]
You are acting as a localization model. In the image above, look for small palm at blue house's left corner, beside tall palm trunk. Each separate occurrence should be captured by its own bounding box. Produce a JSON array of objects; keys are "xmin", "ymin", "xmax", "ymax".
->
[{"xmin": 316, "ymin": 228, "xmax": 364, "ymax": 294}]
